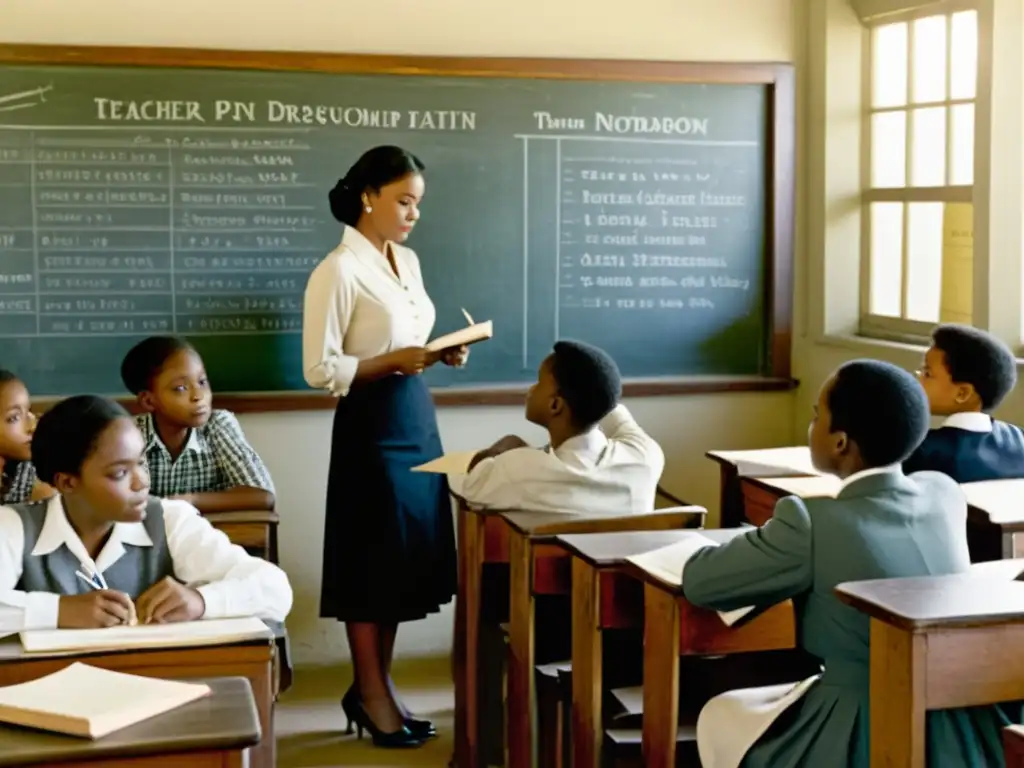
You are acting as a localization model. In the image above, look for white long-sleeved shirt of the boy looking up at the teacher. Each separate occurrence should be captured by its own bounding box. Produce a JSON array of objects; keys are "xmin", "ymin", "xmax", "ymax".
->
[{"xmin": 461, "ymin": 406, "xmax": 665, "ymax": 515}]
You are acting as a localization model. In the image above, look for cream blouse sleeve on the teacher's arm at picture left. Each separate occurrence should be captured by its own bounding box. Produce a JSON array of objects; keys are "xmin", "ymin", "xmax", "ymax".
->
[{"xmin": 302, "ymin": 256, "xmax": 359, "ymax": 396}]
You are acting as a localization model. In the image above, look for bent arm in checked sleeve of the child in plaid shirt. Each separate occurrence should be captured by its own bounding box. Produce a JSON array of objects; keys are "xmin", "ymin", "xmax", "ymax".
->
[{"xmin": 200, "ymin": 411, "xmax": 274, "ymax": 512}]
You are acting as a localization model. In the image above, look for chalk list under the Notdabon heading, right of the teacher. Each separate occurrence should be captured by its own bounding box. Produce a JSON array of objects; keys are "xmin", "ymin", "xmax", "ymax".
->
[{"xmin": 557, "ymin": 139, "xmax": 758, "ymax": 313}]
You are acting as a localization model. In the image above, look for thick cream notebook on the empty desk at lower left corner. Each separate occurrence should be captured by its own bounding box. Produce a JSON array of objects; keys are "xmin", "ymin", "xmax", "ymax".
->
[{"xmin": 0, "ymin": 663, "xmax": 210, "ymax": 738}]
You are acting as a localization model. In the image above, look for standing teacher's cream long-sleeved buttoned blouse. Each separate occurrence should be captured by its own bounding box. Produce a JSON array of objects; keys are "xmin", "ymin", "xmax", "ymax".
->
[{"xmin": 302, "ymin": 226, "xmax": 436, "ymax": 397}]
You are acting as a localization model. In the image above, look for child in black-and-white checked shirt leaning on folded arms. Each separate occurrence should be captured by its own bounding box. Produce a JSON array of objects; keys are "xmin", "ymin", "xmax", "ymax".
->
[{"xmin": 121, "ymin": 336, "xmax": 274, "ymax": 512}]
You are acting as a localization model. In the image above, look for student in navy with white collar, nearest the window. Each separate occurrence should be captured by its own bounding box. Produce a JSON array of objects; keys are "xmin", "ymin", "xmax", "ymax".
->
[{"xmin": 903, "ymin": 325, "xmax": 1024, "ymax": 482}]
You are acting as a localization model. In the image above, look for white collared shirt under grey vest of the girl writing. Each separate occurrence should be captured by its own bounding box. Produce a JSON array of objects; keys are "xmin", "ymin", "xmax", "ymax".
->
[{"xmin": 0, "ymin": 496, "xmax": 292, "ymax": 632}]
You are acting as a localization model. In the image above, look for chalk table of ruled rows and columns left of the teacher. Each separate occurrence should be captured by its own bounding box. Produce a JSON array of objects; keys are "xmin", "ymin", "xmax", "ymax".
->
[{"xmin": 0, "ymin": 130, "xmax": 325, "ymax": 338}]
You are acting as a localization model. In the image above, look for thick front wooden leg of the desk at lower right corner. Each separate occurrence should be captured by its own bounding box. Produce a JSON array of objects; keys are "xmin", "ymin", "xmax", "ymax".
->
[{"xmin": 870, "ymin": 618, "xmax": 928, "ymax": 768}]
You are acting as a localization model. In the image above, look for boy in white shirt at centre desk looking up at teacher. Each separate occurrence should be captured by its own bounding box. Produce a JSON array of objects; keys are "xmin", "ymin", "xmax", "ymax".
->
[{"xmin": 462, "ymin": 341, "xmax": 665, "ymax": 514}]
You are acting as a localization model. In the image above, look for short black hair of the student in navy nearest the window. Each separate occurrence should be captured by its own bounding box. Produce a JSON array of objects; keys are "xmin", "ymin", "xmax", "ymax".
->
[{"xmin": 932, "ymin": 323, "xmax": 1017, "ymax": 411}]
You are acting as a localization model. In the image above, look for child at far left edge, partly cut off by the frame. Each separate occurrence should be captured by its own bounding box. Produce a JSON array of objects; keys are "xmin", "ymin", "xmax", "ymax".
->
[{"xmin": 0, "ymin": 369, "xmax": 56, "ymax": 504}]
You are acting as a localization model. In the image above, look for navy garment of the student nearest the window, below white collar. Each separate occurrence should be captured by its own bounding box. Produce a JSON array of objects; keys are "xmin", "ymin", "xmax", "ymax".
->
[{"xmin": 903, "ymin": 419, "xmax": 1024, "ymax": 482}]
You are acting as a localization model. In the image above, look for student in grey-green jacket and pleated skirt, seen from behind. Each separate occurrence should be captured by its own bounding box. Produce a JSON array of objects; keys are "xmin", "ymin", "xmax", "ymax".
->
[{"xmin": 683, "ymin": 360, "xmax": 1020, "ymax": 768}]
